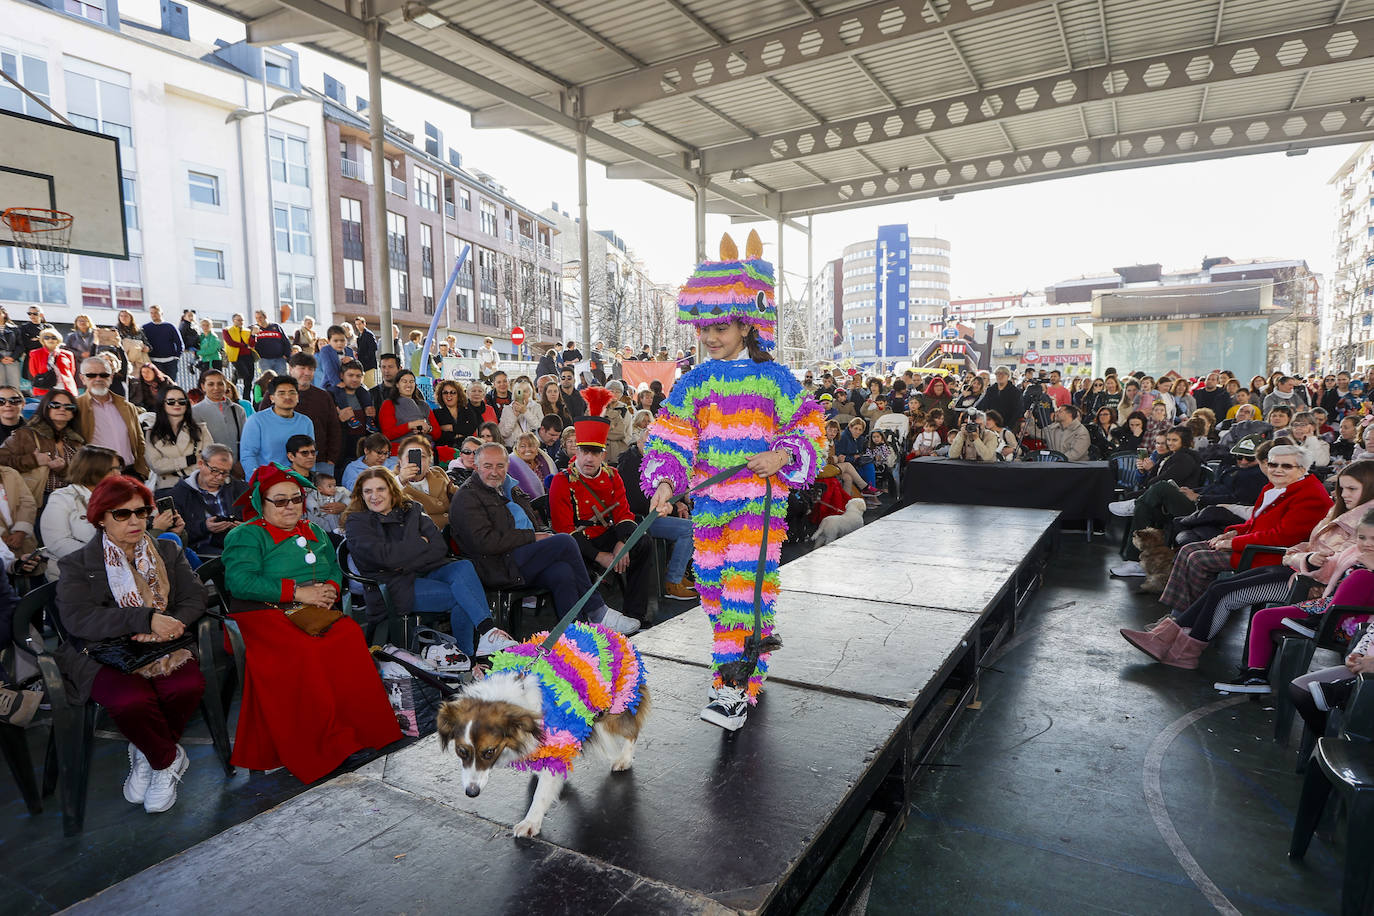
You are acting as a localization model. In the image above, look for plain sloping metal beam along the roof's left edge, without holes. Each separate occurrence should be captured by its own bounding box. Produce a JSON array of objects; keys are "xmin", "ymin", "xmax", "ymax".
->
[{"xmin": 259, "ymin": 0, "xmax": 800, "ymax": 228}]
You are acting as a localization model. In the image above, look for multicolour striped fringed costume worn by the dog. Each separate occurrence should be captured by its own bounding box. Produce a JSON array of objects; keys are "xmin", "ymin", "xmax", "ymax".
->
[{"xmin": 492, "ymin": 623, "xmax": 644, "ymax": 779}]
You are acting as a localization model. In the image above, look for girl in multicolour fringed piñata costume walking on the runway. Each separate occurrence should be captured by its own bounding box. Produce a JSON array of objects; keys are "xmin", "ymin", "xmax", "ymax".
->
[{"xmin": 640, "ymin": 232, "xmax": 824, "ymax": 731}]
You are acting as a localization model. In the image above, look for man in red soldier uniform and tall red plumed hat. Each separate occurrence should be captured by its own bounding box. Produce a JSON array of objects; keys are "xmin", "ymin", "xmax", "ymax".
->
[{"xmin": 548, "ymin": 387, "xmax": 658, "ymax": 621}]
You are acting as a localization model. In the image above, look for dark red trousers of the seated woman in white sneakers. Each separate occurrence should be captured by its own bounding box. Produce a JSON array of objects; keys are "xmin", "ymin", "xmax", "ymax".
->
[{"xmin": 91, "ymin": 661, "xmax": 205, "ymax": 769}]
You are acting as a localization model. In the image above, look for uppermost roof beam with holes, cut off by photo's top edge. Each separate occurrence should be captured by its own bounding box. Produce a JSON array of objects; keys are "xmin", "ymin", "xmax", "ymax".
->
[{"xmin": 583, "ymin": 0, "xmax": 1052, "ymax": 117}]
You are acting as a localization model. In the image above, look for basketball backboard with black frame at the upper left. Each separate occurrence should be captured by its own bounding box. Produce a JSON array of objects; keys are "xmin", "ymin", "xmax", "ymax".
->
[{"xmin": 0, "ymin": 111, "xmax": 129, "ymax": 260}]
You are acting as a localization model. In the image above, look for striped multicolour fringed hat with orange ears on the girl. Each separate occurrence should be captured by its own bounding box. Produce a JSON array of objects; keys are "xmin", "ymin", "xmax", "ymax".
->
[{"xmin": 677, "ymin": 229, "xmax": 778, "ymax": 350}]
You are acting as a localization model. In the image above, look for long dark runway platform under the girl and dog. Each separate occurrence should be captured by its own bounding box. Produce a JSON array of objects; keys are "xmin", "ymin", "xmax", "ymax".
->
[{"xmin": 76, "ymin": 505, "xmax": 1057, "ymax": 913}]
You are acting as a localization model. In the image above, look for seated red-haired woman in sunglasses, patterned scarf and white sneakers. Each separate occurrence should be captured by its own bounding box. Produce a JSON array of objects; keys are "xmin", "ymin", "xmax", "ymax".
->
[{"xmin": 55, "ymin": 475, "xmax": 207, "ymax": 814}]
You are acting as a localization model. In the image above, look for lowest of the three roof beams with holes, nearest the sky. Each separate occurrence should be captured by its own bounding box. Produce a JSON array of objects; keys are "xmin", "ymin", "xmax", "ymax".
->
[{"xmin": 780, "ymin": 102, "xmax": 1374, "ymax": 216}]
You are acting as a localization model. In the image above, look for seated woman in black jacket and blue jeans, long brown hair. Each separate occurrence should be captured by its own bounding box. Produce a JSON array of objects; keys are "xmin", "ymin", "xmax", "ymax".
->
[{"xmin": 344, "ymin": 466, "xmax": 515, "ymax": 656}]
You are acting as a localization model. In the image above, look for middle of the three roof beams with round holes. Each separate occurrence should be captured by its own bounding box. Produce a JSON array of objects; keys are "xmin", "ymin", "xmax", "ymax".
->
[{"xmin": 702, "ymin": 19, "xmax": 1374, "ymax": 174}]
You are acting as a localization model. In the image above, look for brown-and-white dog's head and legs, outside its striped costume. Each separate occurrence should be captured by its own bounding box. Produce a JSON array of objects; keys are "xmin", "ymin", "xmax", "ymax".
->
[{"xmin": 438, "ymin": 659, "xmax": 649, "ymax": 836}]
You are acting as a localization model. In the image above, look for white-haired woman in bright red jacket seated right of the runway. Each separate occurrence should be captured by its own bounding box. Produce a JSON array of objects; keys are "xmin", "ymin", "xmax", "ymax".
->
[{"xmin": 1121, "ymin": 445, "xmax": 1333, "ymax": 669}]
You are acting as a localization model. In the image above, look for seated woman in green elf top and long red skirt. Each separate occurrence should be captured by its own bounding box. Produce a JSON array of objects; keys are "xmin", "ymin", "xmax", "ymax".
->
[{"xmin": 223, "ymin": 464, "xmax": 401, "ymax": 783}]
